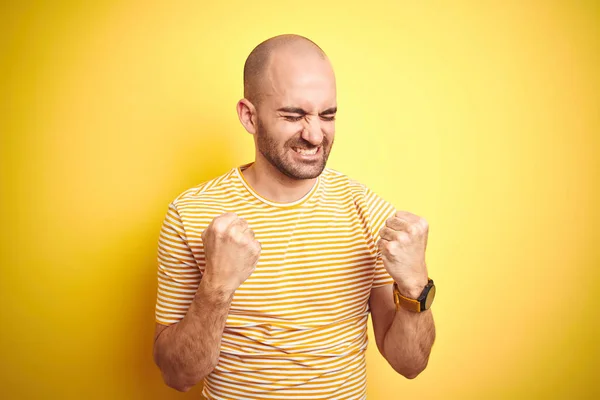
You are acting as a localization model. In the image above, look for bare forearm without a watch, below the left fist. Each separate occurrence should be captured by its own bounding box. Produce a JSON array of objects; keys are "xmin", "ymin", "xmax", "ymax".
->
[{"xmin": 154, "ymin": 280, "xmax": 233, "ymax": 391}]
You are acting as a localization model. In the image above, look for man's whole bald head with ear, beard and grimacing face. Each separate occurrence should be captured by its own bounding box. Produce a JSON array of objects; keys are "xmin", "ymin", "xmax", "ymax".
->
[{"xmin": 236, "ymin": 35, "xmax": 337, "ymax": 180}]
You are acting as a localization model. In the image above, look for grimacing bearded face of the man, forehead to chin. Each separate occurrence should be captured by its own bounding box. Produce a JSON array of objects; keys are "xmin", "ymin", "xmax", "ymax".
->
[{"xmin": 255, "ymin": 51, "xmax": 337, "ymax": 179}]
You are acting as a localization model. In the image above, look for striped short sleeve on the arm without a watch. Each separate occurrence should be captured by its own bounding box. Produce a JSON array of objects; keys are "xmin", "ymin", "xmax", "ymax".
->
[{"xmin": 155, "ymin": 202, "xmax": 202, "ymax": 325}]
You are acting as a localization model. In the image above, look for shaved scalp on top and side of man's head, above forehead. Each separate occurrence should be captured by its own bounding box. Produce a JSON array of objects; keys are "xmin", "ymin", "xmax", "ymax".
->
[{"xmin": 244, "ymin": 34, "xmax": 327, "ymax": 105}]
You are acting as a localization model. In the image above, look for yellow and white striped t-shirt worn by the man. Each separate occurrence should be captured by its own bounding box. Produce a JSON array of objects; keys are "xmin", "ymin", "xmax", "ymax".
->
[{"xmin": 156, "ymin": 164, "xmax": 395, "ymax": 400}]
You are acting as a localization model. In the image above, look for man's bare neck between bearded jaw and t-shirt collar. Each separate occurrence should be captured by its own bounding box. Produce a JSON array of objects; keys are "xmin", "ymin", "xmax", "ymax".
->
[{"xmin": 242, "ymin": 157, "xmax": 317, "ymax": 203}]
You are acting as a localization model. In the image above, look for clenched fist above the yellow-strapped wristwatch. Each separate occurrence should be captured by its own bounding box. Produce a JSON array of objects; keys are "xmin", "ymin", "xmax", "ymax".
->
[{"xmin": 377, "ymin": 211, "xmax": 429, "ymax": 299}]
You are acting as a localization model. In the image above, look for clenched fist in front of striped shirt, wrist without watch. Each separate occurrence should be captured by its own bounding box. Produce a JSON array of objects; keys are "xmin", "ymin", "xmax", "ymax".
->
[{"xmin": 202, "ymin": 213, "xmax": 261, "ymax": 293}]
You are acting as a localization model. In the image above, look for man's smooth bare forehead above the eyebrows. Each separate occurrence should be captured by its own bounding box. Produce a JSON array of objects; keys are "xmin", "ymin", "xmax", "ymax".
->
[{"xmin": 263, "ymin": 53, "xmax": 336, "ymax": 111}]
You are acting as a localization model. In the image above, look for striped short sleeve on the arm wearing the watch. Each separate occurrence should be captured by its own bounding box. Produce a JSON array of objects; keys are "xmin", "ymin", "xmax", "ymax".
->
[{"xmin": 365, "ymin": 188, "xmax": 396, "ymax": 288}]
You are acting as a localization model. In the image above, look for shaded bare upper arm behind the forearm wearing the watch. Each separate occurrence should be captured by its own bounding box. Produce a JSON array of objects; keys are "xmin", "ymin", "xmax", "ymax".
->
[{"xmin": 369, "ymin": 284, "xmax": 396, "ymax": 357}]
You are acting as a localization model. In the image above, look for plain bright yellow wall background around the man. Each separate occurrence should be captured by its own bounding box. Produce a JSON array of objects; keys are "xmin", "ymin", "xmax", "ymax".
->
[{"xmin": 0, "ymin": 0, "xmax": 600, "ymax": 400}]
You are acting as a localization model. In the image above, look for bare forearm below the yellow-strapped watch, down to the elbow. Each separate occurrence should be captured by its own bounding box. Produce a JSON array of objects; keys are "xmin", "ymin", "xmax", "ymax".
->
[{"xmin": 383, "ymin": 308, "xmax": 435, "ymax": 379}]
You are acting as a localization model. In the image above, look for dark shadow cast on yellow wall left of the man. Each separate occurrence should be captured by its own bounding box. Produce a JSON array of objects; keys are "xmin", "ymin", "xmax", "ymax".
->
[{"xmin": 114, "ymin": 117, "xmax": 239, "ymax": 399}]
